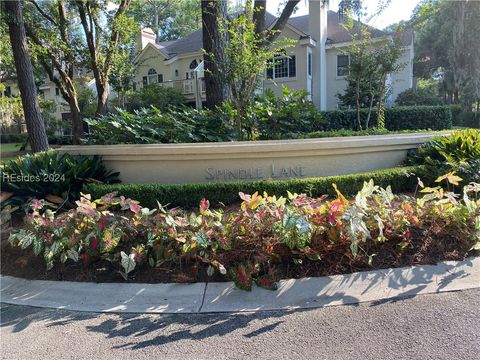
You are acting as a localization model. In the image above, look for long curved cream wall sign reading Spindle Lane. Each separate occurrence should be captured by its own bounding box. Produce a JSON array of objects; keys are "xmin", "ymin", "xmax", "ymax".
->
[{"xmin": 58, "ymin": 133, "xmax": 434, "ymax": 184}]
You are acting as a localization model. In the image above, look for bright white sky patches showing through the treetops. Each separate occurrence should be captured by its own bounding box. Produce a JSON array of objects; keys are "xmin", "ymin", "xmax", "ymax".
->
[{"xmin": 267, "ymin": 0, "xmax": 420, "ymax": 29}]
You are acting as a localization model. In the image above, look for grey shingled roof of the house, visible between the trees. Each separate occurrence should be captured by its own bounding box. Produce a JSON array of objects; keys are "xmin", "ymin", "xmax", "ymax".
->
[{"xmin": 148, "ymin": 10, "xmax": 412, "ymax": 58}]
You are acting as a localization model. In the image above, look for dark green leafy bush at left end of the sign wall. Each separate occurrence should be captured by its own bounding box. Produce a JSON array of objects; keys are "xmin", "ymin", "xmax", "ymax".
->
[{"xmin": 0, "ymin": 150, "xmax": 119, "ymax": 205}]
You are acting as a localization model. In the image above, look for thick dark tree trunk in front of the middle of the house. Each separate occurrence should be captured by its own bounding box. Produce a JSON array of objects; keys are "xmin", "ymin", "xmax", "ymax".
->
[{"xmin": 201, "ymin": 0, "xmax": 228, "ymax": 109}]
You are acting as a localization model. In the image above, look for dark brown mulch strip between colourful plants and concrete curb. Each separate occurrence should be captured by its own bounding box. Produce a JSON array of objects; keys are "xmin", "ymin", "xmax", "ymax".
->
[{"xmin": 1, "ymin": 222, "xmax": 479, "ymax": 283}]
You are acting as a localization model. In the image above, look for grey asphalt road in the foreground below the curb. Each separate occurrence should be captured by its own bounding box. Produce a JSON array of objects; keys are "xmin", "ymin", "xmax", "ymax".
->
[{"xmin": 1, "ymin": 289, "xmax": 480, "ymax": 360}]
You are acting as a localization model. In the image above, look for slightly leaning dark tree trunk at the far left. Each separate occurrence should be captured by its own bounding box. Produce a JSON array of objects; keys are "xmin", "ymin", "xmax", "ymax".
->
[{"xmin": 4, "ymin": 0, "xmax": 48, "ymax": 152}]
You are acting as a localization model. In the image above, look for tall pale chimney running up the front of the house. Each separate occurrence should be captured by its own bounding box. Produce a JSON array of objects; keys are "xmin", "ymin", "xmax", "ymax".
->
[{"xmin": 308, "ymin": 0, "xmax": 328, "ymax": 110}]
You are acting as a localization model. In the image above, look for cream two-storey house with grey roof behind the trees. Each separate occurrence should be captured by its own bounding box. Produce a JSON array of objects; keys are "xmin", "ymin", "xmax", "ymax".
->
[{"xmin": 133, "ymin": 1, "xmax": 413, "ymax": 110}]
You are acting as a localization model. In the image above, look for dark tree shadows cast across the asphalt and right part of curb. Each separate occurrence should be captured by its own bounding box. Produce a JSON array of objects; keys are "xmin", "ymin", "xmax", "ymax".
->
[{"xmin": 0, "ymin": 262, "xmax": 471, "ymax": 350}]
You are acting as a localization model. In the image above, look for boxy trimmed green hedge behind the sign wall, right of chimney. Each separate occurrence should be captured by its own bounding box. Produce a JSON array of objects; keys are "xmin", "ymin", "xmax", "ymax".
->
[{"xmin": 318, "ymin": 106, "xmax": 452, "ymax": 130}]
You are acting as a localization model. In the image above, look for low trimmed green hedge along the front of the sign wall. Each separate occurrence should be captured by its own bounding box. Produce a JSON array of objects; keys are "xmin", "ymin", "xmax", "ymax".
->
[{"xmin": 84, "ymin": 166, "xmax": 423, "ymax": 208}]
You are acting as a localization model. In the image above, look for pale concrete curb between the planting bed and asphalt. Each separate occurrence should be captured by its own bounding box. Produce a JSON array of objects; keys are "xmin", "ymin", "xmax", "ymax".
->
[{"xmin": 0, "ymin": 257, "xmax": 480, "ymax": 314}]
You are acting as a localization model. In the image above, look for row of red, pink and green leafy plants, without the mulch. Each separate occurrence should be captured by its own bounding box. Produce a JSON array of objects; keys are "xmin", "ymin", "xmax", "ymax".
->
[{"xmin": 4, "ymin": 174, "xmax": 480, "ymax": 290}]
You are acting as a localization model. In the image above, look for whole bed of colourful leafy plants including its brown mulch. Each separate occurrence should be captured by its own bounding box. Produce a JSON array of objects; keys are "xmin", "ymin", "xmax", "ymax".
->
[{"xmin": 2, "ymin": 173, "xmax": 480, "ymax": 290}]
